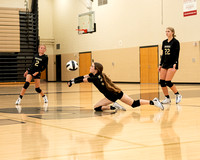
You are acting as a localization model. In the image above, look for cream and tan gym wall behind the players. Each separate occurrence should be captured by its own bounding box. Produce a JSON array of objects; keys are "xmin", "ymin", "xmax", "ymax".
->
[{"xmin": 39, "ymin": 0, "xmax": 200, "ymax": 83}]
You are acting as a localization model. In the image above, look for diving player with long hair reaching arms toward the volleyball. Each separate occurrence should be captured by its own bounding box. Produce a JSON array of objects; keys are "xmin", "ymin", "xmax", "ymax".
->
[{"xmin": 67, "ymin": 62, "xmax": 164, "ymax": 111}]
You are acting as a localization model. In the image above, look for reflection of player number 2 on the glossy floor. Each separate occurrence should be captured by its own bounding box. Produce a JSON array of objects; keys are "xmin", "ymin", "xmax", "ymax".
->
[{"xmin": 15, "ymin": 103, "xmax": 49, "ymax": 159}]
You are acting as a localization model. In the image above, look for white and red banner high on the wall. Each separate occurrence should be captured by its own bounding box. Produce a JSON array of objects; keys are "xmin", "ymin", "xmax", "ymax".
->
[{"xmin": 183, "ymin": 0, "xmax": 197, "ymax": 17}]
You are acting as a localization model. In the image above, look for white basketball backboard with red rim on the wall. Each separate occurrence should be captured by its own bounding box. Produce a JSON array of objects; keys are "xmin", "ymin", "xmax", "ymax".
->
[{"xmin": 78, "ymin": 11, "xmax": 96, "ymax": 34}]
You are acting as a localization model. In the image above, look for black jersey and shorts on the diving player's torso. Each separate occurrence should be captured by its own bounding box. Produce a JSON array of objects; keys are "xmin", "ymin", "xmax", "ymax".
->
[{"xmin": 87, "ymin": 73, "xmax": 123, "ymax": 102}]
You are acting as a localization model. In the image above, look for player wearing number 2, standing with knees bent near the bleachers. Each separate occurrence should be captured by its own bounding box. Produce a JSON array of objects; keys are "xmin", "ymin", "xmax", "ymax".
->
[{"xmin": 15, "ymin": 45, "xmax": 48, "ymax": 105}]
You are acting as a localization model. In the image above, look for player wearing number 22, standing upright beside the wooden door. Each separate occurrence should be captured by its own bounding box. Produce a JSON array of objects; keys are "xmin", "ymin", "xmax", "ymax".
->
[{"xmin": 158, "ymin": 27, "xmax": 182, "ymax": 104}]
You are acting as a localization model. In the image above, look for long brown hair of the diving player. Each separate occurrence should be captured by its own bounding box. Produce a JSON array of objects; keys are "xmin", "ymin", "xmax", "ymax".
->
[{"xmin": 94, "ymin": 62, "xmax": 121, "ymax": 93}]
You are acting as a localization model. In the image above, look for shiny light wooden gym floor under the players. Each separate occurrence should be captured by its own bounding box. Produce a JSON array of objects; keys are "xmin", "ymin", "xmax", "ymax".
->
[{"xmin": 0, "ymin": 82, "xmax": 200, "ymax": 160}]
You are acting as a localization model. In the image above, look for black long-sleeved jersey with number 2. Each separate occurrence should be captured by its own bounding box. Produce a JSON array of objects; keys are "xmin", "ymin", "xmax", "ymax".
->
[{"xmin": 28, "ymin": 54, "xmax": 48, "ymax": 73}]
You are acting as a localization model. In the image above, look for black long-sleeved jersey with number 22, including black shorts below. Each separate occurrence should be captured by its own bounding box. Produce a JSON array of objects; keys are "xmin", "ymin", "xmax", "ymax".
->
[{"xmin": 160, "ymin": 38, "xmax": 180, "ymax": 69}]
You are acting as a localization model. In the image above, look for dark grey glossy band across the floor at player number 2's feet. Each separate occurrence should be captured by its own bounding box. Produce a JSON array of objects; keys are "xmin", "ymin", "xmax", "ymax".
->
[{"xmin": 0, "ymin": 103, "xmax": 118, "ymax": 122}]
